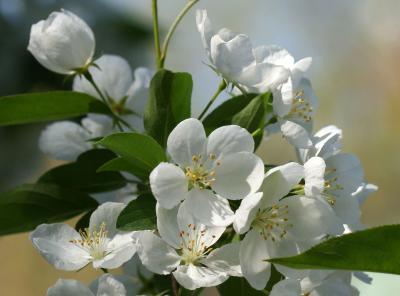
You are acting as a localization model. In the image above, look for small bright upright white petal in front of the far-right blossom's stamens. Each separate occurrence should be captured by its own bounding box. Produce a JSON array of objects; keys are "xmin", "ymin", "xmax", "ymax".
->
[{"xmin": 304, "ymin": 157, "xmax": 326, "ymax": 197}]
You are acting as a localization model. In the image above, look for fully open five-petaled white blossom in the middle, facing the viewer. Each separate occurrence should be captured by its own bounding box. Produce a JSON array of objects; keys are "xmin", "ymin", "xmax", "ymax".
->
[{"xmin": 150, "ymin": 118, "xmax": 264, "ymax": 226}]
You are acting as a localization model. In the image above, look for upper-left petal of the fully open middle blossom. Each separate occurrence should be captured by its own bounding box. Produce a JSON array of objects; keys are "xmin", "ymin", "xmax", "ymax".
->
[{"xmin": 167, "ymin": 118, "xmax": 207, "ymax": 168}]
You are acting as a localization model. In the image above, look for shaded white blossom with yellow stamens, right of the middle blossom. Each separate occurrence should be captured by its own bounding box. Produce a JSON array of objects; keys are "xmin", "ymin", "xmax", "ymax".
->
[{"xmin": 233, "ymin": 163, "xmax": 336, "ymax": 290}]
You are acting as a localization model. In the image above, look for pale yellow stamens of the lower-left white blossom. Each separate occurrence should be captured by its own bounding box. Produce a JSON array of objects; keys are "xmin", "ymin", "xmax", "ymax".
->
[{"xmin": 69, "ymin": 222, "xmax": 108, "ymax": 260}]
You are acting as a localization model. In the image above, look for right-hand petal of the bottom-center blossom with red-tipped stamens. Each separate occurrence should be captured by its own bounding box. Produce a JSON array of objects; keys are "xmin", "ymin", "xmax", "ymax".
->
[{"xmin": 201, "ymin": 243, "xmax": 242, "ymax": 276}]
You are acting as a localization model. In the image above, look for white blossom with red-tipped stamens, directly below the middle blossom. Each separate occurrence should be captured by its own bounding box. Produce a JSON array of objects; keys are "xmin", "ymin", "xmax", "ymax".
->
[{"xmin": 138, "ymin": 204, "xmax": 241, "ymax": 290}]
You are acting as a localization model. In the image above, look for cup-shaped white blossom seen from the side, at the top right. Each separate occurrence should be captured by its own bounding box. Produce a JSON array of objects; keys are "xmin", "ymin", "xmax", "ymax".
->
[{"xmin": 196, "ymin": 10, "xmax": 289, "ymax": 92}]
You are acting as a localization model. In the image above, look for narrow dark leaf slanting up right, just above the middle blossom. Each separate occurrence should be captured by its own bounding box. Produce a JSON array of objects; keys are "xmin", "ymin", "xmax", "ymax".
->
[{"xmin": 203, "ymin": 94, "xmax": 257, "ymax": 132}]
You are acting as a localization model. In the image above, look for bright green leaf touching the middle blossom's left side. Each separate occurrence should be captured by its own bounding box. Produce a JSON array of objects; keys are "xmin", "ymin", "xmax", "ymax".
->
[{"xmin": 98, "ymin": 133, "xmax": 167, "ymax": 179}]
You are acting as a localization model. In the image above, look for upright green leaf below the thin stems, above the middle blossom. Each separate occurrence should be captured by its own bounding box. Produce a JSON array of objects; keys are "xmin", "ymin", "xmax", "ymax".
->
[{"xmin": 144, "ymin": 69, "xmax": 193, "ymax": 147}]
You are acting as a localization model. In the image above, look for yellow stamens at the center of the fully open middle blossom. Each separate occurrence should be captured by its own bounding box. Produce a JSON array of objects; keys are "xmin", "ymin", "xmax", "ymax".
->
[{"xmin": 185, "ymin": 153, "xmax": 220, "ymax": 189}]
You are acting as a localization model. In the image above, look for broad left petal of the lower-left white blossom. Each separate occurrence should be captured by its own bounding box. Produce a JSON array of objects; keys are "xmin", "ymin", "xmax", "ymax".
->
[{"xmin": 30, "ymin": 223, "xmax": 90, "ymax": 270}]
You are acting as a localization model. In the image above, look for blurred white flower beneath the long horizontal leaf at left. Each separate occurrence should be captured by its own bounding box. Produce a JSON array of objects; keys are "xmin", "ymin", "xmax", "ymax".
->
[{"xmin": 39, "ymin": 114, "xmax": 112, "ymax": 160}]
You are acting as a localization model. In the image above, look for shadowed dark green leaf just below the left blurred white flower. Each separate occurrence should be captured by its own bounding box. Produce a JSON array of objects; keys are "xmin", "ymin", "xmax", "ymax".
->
[{"xmin": 38, "ymin": 149, "xmax": 126, "ymax": 193}]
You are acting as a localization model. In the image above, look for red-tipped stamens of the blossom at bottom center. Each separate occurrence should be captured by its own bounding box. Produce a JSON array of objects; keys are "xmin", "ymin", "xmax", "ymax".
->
[{"xmin": 179, "ymin": 224, "xmax": 211, "ymax": 264}]
